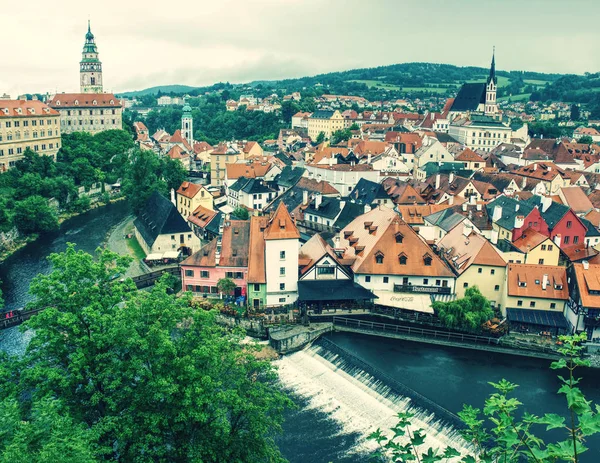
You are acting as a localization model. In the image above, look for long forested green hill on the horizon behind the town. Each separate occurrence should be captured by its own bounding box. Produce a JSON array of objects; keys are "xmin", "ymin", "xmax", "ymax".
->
[{"xmin": 122, "ymin": 63, "xmax": 562, "ymax": 100}]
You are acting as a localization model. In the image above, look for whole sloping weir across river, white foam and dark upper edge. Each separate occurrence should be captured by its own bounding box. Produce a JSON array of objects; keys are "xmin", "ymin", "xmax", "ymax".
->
[{"xmin": 276, "ymin": 338, "xmax": 471, "ymax": 461}]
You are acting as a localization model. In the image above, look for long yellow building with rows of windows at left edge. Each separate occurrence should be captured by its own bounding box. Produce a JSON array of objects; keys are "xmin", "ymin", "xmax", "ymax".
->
[{"xmin": 0, "ymin": 100, "xmax": 60, "ymax": 172}]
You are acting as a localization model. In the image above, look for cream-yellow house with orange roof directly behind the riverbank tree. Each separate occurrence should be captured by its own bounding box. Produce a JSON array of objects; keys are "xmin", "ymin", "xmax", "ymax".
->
[{"xmin": 438, "ymin": 225, "xmax": 506, "ymax": 309}]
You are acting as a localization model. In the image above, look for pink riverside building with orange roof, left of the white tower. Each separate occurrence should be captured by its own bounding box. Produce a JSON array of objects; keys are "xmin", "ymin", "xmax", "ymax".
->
[{"xmin": 181, "ymin": 220, "xmax": 250, "ymax": 297}]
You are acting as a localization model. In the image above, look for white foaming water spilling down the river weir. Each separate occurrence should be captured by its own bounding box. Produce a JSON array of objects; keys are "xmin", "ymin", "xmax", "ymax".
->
[{"xmin": 275, "ymin": 346, "xmax": 470, "ymax": 462}]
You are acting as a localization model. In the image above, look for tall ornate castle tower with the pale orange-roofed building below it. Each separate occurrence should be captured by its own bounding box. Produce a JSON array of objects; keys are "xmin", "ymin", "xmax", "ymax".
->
[{"xmin": 48, "ymin": 21, "xmax": 123, "ymax": 134}]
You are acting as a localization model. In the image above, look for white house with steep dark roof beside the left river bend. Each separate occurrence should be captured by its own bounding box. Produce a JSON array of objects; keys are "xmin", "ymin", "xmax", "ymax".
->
[{"xmin": 134, "ymin": 191, "xmax": 200, "ymax": 255}]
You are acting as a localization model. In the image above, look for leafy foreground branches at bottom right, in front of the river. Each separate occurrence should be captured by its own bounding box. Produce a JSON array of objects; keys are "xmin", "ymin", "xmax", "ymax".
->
[{"xmin": 369, "ymin": 333, "xmax": 600, "ymax": 463}]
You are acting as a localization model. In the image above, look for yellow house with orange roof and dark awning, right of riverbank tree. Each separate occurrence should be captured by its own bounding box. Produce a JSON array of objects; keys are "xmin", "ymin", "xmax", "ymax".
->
[{"xmin": 503, "ymin": 264, "xmax": 569, "ymax": 326}]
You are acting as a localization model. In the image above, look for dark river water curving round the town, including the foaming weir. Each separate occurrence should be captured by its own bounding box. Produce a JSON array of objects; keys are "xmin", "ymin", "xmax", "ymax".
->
[{"xmin": 0, "ymin": 202, "xmax": 600, "ymax": 463}]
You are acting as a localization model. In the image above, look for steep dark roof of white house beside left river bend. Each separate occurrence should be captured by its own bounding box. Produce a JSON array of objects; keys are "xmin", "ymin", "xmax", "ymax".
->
[{"xmin": 134, "ymin": 190, "xmax": 191, "ymax": 247}]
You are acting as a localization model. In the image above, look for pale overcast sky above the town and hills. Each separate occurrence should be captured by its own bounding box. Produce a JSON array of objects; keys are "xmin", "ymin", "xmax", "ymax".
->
[{"xmin": 0, "ymin": 0, "xmax": 600, "ymax": 97}]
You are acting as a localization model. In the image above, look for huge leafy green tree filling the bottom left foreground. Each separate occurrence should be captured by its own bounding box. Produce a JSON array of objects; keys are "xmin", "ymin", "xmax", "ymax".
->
[{"xmin": 0, "ymin": 245, "xmax": 291, "ymax": 462}]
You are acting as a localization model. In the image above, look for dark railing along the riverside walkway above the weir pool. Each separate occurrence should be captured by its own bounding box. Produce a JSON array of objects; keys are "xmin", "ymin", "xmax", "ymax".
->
[{"xmin": 333, "ymin": 317, "xmax": 500, "ymax": 345}]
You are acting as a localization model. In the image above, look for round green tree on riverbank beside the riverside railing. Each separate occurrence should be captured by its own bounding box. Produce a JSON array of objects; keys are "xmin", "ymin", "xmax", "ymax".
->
[{"xmin": 432, "ymin": 286, "xmax": 494, "ymax": 330}]
